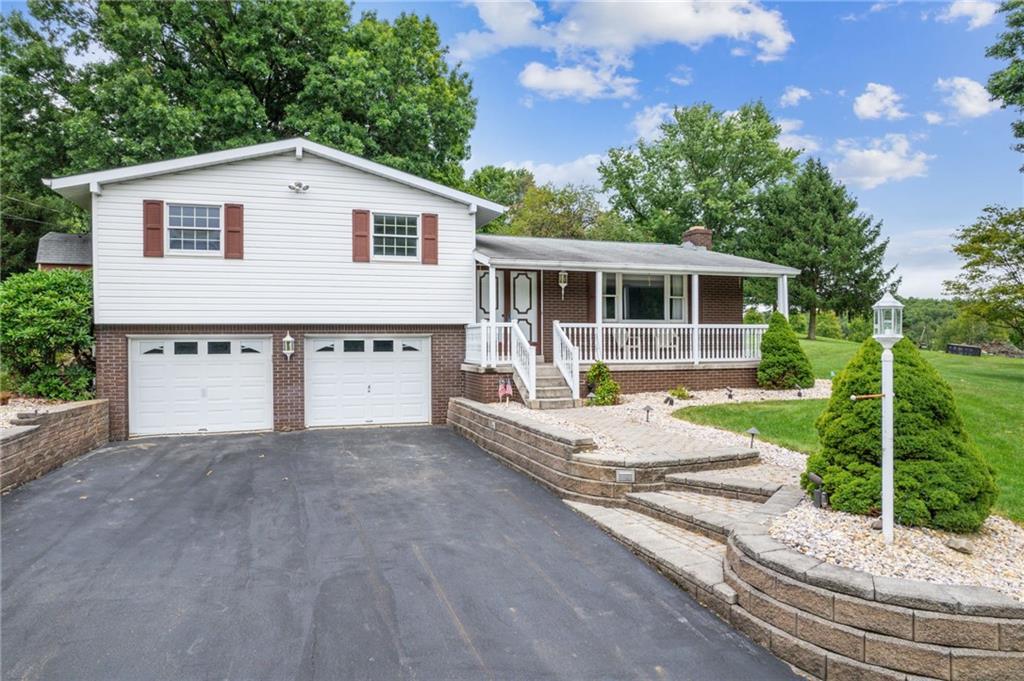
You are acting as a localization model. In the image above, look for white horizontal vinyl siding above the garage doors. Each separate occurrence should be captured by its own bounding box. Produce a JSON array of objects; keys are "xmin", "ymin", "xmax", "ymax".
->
[{"xmin": 93, "ymin": 153, "xmax": 475, "ymax": 324}]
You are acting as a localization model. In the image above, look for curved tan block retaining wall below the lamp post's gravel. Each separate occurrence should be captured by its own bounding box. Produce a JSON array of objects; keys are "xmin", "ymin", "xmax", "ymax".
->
[{"xmin": 725, "ymin": 491, "xmax": 1024, "ymax": 681}]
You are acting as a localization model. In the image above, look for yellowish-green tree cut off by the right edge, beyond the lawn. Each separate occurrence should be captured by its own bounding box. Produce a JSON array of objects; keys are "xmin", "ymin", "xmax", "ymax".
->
[{"xmin": 945, "ymin": 206, "xmax": 1024, "ymax": 344}]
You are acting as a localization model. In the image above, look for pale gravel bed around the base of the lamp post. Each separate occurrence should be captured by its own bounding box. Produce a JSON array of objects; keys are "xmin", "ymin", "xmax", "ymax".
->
[{"xmin": 769, "ymin": 501, "xmax": 1024, "ymax": 601}]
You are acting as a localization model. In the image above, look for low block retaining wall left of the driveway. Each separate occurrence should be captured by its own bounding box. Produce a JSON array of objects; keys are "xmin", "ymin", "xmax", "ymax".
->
[{"xmin": 0, "ymin": 399, "xmax": 110, "ymax": 492}]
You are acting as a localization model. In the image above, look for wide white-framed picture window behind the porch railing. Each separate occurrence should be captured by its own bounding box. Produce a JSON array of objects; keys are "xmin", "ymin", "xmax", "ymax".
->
[{"xmin": 601, "ymin": 272, "xmax": 689, "ymax": 323}]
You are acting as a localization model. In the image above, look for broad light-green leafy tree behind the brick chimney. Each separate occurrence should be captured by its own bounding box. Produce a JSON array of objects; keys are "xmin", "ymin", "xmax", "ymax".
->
[{"xmin": 600, "ymin": 101, "xmax": 798, "ymax": 253}]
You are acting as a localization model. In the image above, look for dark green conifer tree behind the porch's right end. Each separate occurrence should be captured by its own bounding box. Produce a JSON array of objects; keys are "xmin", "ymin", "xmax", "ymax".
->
[{"xmin": 745, "ymin": 159, "xmax": 894, "ymax": 338}]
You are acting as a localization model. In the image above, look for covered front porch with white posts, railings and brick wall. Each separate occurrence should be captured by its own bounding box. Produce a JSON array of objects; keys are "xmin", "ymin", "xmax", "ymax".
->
[{"xmin": 465, "ymin": 236, "xmax": 796, "ymax": 399}]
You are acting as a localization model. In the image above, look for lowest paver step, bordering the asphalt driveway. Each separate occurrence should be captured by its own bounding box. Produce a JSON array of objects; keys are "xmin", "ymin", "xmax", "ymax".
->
[{"xmin": 565, "ymin": 501, "xmax": 737, "ymax": 616}]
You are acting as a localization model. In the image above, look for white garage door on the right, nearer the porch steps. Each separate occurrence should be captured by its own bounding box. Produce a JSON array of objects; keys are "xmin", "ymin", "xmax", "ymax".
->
[{"xmin": 305, "ymin": 336, "xmax": 430, "ymax": 426}]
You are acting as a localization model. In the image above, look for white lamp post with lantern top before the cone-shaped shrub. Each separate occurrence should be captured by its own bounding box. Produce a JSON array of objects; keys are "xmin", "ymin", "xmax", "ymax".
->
[{"xmin": 871, "ymin": 291, "xmax": 903, "ymax": 544}]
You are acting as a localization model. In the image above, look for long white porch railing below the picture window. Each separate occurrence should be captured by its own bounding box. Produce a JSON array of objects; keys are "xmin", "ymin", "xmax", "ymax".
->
[{"xmin": 559, "ymin": 323, "xmax": 768, "ymax": 364}]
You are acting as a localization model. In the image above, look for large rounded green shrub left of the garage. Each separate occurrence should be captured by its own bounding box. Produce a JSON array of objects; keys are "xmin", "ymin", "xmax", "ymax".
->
[{"xmin": 0, "ymin": 269, "xmax": 95, "ymax": 399}]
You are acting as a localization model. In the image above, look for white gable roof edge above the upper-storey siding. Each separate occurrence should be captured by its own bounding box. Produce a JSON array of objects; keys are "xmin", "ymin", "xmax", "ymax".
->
[{"xmin": 43, "ymin": 137, "xmax": 506, "ymax": 227}]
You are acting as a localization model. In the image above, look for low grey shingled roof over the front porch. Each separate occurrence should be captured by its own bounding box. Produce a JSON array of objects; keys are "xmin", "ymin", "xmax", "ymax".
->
[{"xmin": 476, "ymin": 235, "xmax": 800, "ymax": 276}]
